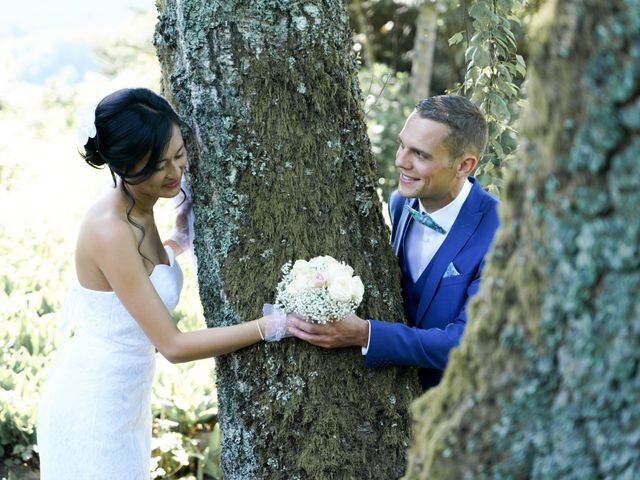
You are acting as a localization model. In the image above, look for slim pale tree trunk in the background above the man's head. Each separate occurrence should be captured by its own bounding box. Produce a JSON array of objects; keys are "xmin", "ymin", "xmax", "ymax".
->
[{"xmin": 411, "ymin": 0, "xmax": 438, "ymax": 103}]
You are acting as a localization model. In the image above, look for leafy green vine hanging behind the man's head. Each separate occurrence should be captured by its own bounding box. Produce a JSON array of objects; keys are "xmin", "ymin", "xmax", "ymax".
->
[{"xmin": 449, "ymin": 0, "xmax": 526, "ymax": 194}]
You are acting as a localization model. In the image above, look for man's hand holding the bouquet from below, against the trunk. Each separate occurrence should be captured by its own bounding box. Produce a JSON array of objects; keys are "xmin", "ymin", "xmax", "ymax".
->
[{"xmin": 289, "ymin": 315, "xmax": 369, "ymax": 348}]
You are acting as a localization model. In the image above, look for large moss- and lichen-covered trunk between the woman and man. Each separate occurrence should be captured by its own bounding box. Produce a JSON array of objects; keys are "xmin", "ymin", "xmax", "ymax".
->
[{"xmin": 151, "ymin": 0, "xmax": 418, "ymax": 480}]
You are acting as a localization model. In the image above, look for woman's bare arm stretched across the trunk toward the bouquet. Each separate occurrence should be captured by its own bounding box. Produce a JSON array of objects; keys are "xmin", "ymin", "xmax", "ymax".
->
[{"xmin": 93, "ymin": 222, "xmax": 270, "ymax": 363}]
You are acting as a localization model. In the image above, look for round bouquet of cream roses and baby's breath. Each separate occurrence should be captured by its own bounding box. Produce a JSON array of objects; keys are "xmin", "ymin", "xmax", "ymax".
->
[{"xmin": 275, "ymin": 256, "xmax": 364, "ymax": 323}]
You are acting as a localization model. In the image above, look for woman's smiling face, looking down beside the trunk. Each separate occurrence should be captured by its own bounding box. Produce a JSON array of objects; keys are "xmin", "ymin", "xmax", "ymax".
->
[{"xmin": 132, "ymin": 125, "xmax": 187, "ymax": 198}]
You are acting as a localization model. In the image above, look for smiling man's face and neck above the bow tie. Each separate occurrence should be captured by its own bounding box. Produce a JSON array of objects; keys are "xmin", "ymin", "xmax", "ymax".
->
[{"xmin": 396, "ymin": 111, "xmax": 466, "ymax": 212}]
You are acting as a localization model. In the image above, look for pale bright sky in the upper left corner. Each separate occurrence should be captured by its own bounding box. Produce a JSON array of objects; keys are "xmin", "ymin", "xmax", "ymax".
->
[{"xmin": 0, "ymin": 0, "xmax": 155, "ymax": 84}]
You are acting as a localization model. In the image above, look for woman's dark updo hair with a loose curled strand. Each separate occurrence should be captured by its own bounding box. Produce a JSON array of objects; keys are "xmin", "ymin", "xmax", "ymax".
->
[{"xmin": 80, "ymin": 88, "xmax": 187, "ymax": 260}]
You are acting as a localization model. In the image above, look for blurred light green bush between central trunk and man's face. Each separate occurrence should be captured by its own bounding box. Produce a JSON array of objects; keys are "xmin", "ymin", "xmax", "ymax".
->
[{"xmin": 359, "ymin": 63, "xmax": 415, "ymax": 199}]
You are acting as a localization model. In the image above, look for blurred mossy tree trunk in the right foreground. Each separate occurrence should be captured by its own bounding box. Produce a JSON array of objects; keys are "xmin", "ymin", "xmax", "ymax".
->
[{"xmin": 406, "ymin": 0, "xmax": 640, "ymax": 479}]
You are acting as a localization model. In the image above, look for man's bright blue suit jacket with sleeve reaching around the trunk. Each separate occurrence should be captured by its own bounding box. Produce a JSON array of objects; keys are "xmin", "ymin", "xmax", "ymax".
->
[{"xmin": 365, "ymin": 177, "xmax": 498, "ymax": 389}]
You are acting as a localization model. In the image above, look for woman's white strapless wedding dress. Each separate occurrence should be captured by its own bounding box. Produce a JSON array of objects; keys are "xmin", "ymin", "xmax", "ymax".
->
[{"xmin": 37, "ymin": 248, "xmax": 182, "ymax": 480}]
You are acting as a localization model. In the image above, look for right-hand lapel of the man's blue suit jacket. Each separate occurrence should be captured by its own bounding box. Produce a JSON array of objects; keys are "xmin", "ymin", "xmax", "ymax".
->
[{"xmin": 416, "ymin": 183, "xmax": 483, "ymax": 325}]
